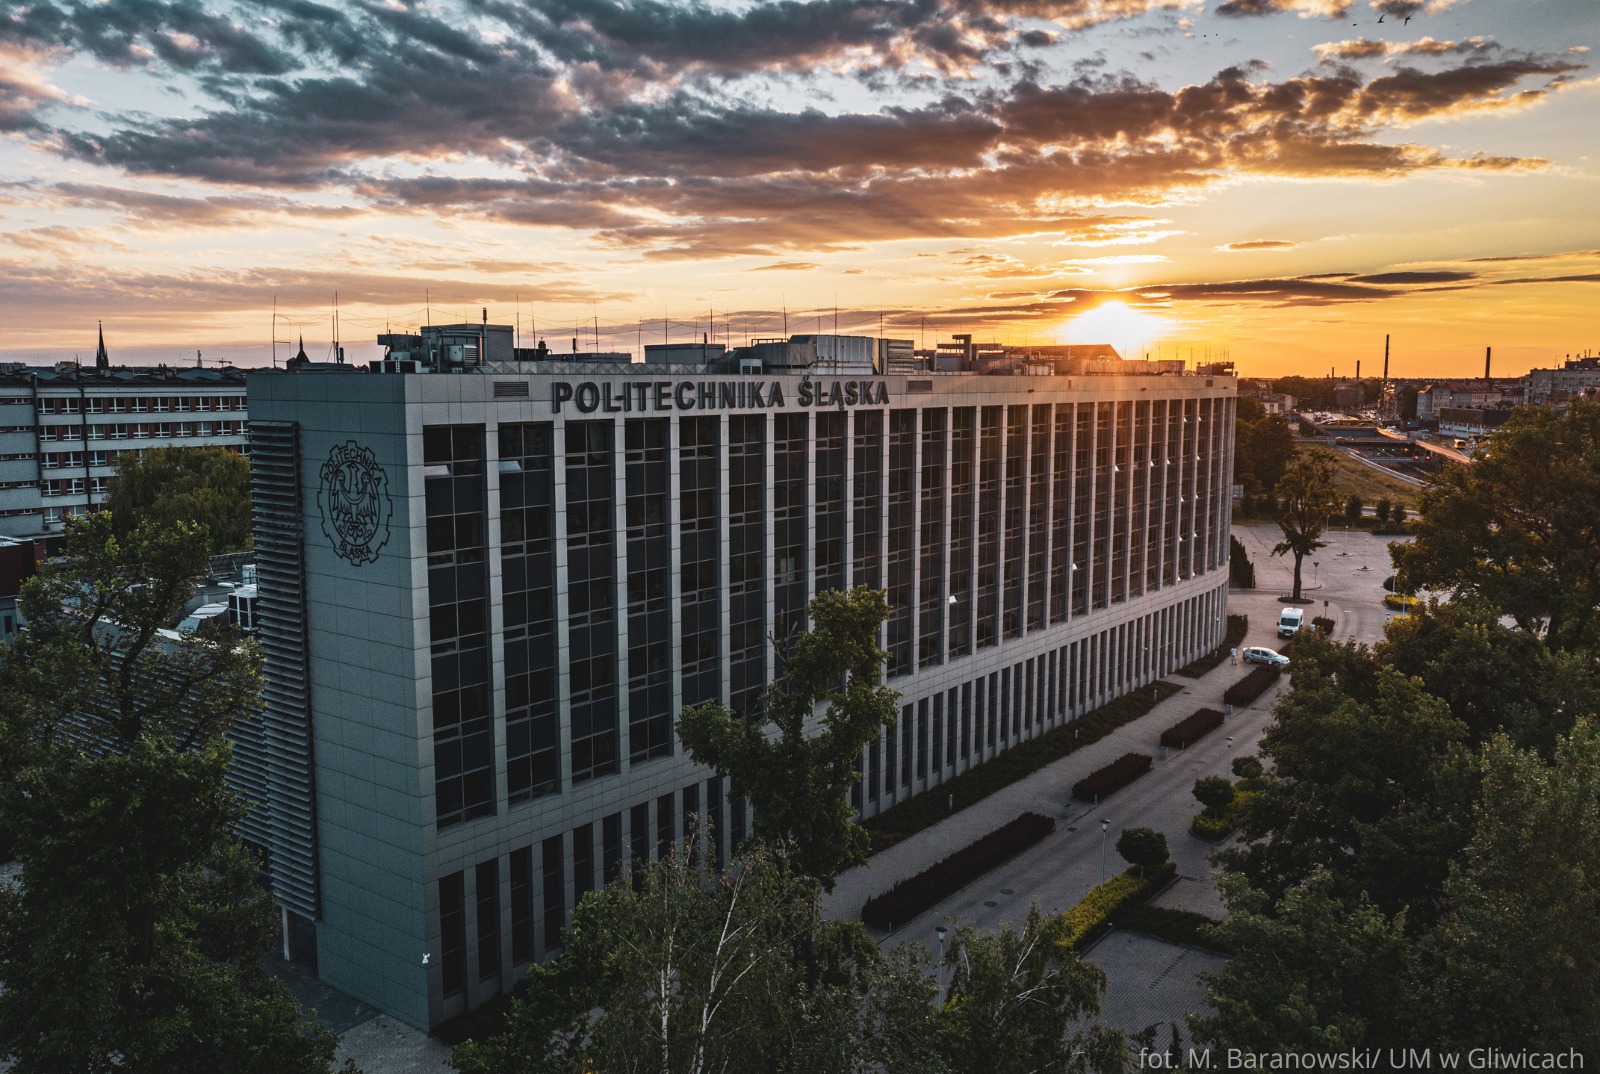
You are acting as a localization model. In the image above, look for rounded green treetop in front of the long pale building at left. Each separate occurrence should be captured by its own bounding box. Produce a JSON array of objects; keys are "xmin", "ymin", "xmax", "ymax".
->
[{"xmin": 106, "ymin": 447, "xmax": 251, "ymax": 555}]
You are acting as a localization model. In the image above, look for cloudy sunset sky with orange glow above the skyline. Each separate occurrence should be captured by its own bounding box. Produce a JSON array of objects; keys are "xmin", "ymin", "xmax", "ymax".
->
[{"xmin": 0, "ymin": 0, "xmax": 1600, "ymax": 378}]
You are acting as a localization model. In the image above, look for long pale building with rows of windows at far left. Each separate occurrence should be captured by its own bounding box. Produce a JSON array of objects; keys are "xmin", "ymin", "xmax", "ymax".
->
[{"xmin": 0, "ymin": 365, "xmax": 246, "ymax": 538}]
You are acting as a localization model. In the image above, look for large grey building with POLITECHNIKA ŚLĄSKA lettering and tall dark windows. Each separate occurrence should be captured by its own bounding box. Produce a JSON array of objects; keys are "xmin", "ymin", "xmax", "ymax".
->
[{"xmin": 242, "ymin": 348, "xmax": 1235, "ymax": 1028}]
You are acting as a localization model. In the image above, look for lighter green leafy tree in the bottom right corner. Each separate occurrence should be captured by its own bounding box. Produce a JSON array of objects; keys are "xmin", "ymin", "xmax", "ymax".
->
[{"xmin": 1430, "ymin": 719, "xmax": 1600, "ymax": 1055}]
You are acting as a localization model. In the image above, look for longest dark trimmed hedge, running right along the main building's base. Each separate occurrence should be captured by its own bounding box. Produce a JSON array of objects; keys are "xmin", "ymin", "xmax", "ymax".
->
[{"xmin": 861, "ymin": 682, "xmax": 1181, "ymax": 853}]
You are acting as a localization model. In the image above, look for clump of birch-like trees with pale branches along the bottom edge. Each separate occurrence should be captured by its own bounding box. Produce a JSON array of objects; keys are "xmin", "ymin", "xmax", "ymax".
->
[{"xmin": 451, "ymin": 844, "xmax": 1123, "ymax": 1074}]
